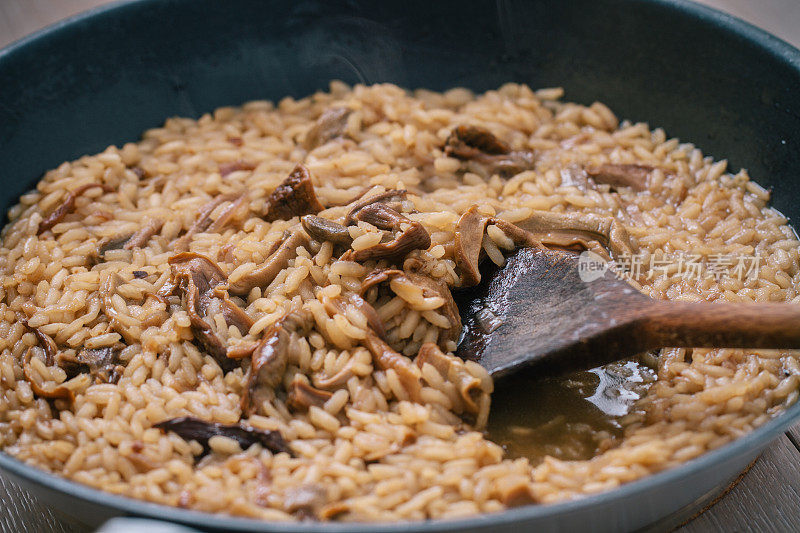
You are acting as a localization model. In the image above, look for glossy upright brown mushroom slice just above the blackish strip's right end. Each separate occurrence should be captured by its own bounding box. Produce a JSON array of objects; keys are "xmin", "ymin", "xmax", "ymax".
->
[{"xmin": 241, "ymin": 311, "xmax": 312, "ymax": 414}]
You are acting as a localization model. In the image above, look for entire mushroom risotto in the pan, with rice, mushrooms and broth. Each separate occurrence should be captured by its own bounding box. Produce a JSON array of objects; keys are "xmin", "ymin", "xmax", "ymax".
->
[{"xmin": 0, "ymin": 82, "xmax": 800, "ymax": 521}]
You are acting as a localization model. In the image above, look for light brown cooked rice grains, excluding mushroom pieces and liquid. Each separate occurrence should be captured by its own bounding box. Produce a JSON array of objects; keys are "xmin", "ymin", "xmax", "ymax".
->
[{"xmin": 0, "ymin": 82, "xmax": 800, "ymax": 521}]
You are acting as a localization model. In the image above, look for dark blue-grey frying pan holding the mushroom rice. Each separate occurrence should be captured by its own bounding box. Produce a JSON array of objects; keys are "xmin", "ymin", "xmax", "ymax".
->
[{"xmin": 0, "ymin": 0, "xmax": 800, "ymax": 533}]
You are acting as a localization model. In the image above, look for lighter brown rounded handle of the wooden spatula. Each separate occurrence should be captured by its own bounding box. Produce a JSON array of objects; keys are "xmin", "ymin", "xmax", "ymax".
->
[{"xmin": 643, "ymin": 301, "xmax": 800, "ymax": 349}]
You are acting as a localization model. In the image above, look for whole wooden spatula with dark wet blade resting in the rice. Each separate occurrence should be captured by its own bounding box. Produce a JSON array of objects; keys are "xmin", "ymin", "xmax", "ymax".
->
[{"xmin": 456, "ymin": 248, "xmax": 800, "ymax": 377}]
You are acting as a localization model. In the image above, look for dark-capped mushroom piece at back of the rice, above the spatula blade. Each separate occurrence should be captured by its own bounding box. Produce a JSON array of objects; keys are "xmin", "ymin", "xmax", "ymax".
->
[{"xmin": 444, "ymin": 125, "xmax": 534, "ymax": 176}]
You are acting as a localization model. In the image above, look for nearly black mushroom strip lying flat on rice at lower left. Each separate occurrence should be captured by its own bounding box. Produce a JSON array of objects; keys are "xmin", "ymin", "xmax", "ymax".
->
[{"xmin": 153, "ymin": 416, "xmax": 292, "ymax": 457}]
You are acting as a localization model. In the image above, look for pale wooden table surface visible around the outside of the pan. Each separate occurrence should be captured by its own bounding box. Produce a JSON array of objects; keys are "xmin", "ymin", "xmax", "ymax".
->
[{"xmin": 0, "ymin": 0, "xmax": 800, "ymax": 533}]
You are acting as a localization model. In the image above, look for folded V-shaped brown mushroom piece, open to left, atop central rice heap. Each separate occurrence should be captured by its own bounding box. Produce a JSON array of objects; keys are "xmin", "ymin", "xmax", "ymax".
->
[{"xmin": 351, "ymin": 203, "xmax": 431, "ymax": 262}]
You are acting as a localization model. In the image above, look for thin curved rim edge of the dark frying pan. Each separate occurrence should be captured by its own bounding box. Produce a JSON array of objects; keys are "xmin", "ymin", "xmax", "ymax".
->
[{"xmin": 0, "ymin": 0, "xmax": 800, "ymax": 533}]
